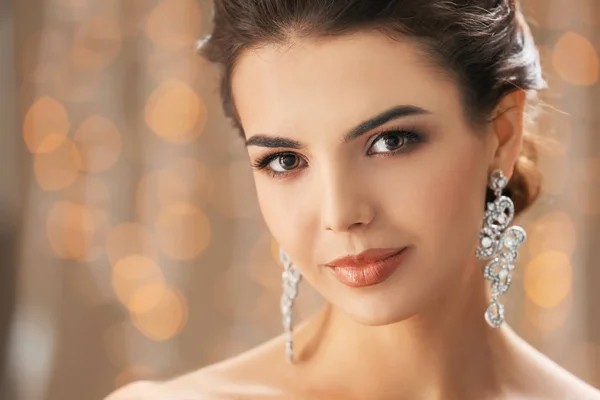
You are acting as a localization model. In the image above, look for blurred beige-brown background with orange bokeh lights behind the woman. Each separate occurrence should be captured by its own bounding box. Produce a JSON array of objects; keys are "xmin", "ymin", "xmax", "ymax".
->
[{"xmin": 0, "ymin": 0, "xmax": 600, "ymax": 400}]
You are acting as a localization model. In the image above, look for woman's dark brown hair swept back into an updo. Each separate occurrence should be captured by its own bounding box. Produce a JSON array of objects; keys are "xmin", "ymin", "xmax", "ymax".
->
[{"xmin": 199, "ymin": 0, "xmax": 546, "ymax": 212}]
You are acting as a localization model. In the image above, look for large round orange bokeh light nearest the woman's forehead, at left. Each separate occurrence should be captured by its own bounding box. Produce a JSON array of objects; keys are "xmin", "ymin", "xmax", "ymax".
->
[{"xmin": 145, "ymin": 79, "xmax": 207, "ymax": 144}]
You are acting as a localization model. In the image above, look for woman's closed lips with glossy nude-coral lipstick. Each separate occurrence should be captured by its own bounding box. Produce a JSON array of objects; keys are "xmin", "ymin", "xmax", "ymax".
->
[{"xmin": 325, "ymin": 247, "xmax": 408, "ymax": 287}]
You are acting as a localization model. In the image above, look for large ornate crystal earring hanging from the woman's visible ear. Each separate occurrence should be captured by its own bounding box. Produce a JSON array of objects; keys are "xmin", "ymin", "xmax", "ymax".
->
[{"xmin": 475, "ymin": 169, "xmax": 526, "ymax": 328}]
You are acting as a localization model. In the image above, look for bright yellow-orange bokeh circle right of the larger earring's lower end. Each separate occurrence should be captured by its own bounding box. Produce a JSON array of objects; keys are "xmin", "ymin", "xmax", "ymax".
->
[{"xmin": 523, "ymin": 251, "xmax": 573, "ymax": 308}]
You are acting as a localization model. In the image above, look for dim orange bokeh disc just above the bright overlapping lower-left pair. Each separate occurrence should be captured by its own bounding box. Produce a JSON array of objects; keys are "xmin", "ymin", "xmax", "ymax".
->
[{"xmin": 106, "ymin": 222, "xmax": 156, "ymax": 265}]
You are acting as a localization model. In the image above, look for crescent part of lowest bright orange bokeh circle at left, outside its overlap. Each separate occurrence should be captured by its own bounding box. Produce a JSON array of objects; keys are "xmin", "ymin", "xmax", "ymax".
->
[{"xmin": 131, "ymin": 288, "xmax": 188, "ymax": 341}]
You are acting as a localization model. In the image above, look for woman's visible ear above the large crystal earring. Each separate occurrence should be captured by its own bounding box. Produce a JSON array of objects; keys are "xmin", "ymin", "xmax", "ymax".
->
[{"xmin": 491, "ymin": 89, "xmax": 526, "ymax": 180}]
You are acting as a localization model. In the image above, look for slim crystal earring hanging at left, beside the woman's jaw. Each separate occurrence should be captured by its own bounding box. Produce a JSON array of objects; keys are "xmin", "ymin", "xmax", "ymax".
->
[{"xmin": 279, "ymin": 247, "xmax": 302, "ymax": 362}]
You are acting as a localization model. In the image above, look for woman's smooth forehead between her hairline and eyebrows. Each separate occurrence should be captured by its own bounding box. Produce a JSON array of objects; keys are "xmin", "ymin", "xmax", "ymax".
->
[{"xmin": 232, "ymin": 33, "xmax": 460, "ymax": 133}]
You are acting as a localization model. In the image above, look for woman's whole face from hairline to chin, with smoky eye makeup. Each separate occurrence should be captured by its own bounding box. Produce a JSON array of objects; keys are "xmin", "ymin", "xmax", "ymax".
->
[{"xmin": 232, "ymin": 33, "xmax": 495, "ymax": 325}]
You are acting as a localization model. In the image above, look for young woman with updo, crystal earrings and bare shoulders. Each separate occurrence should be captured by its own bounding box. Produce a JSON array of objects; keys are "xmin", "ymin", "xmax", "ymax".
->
[{"xmin": 109, "ymin": 0, "xmax": 600, "ymax": 400}]
